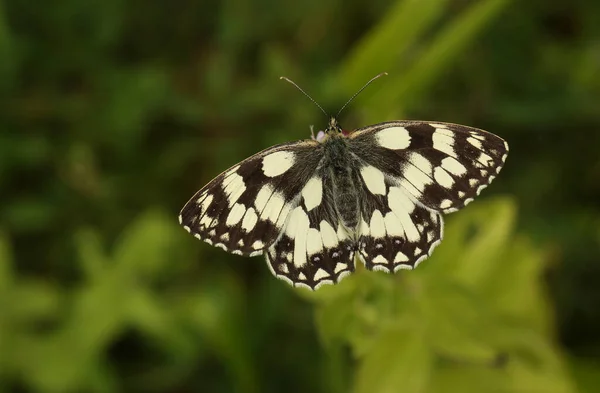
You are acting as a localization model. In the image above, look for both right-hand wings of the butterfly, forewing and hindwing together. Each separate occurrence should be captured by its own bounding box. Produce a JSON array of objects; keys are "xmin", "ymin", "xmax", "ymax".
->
[{"xmin": 349, "ymin": 121, "xmax": 508, "ymax": 272}]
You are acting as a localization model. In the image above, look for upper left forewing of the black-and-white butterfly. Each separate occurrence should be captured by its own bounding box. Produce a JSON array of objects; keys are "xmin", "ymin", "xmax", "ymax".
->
[{"xmin": 179, "ymin": 140, "xmax": 322, "ymax": 256}]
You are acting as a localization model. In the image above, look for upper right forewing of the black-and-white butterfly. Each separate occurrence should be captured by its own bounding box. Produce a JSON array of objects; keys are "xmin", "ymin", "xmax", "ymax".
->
[{"xmin": 349, "ymin": 121, "xmax": 508, "ymax": 213}]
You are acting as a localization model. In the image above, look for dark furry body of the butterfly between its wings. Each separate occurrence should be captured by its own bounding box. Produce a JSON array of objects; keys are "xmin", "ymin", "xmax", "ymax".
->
[{"xmin": 323, "ymin": 130, "xmax": 360, "ymax": 230}]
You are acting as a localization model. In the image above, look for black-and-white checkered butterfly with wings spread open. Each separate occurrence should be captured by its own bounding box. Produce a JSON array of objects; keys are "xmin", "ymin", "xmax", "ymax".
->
[{"xmin": 179, "ymin": 78, "xmax": 508, "ymax": 290}]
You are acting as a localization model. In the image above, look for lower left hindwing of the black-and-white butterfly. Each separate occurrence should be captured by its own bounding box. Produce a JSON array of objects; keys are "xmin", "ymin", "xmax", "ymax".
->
[{"xmin": 265, "ymin": 171, "xmax": 355, "ymax": 289}]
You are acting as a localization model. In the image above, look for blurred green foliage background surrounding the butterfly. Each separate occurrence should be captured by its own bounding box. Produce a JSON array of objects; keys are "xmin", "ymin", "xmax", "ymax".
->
[{"xmin": 0, "ymin": 0, "xmax": 600, "ymax": 393}]
